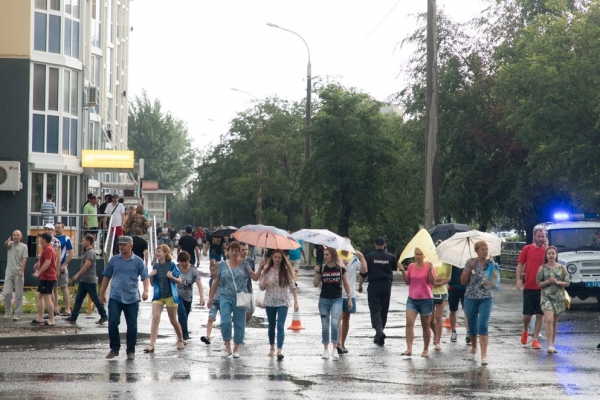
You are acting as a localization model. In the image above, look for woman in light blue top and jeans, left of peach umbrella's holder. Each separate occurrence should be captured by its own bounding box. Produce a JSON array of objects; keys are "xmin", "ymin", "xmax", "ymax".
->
[{"xmin": 207, "ymin": 242, "xmax": 262, "ymax": 358}]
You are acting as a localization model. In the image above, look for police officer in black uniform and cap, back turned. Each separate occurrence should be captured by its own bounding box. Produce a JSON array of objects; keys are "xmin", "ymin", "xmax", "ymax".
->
[{"xmin": 358, "ymin": 236, "xmax": 396, "ymax": 346}]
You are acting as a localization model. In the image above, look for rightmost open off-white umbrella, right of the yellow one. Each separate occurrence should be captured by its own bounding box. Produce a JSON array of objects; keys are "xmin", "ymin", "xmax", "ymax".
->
[{"xmin": 436, "ymin": 230, "xmax": 502, "ymax": 268}]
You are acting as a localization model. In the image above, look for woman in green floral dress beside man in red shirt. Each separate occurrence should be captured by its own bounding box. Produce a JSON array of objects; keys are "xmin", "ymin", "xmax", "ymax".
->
[{"xmin": 536, "ymin": 246, "xmax": 570, "ymax": 354}]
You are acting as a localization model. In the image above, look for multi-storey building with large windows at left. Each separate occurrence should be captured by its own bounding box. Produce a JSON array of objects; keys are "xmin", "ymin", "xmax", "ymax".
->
[{"xmin": 0, "ymin": 0, "xmax": 133, "ymax": 270}]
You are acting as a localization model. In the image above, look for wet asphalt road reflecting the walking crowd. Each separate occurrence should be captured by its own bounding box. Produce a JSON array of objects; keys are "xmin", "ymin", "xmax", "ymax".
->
[{"xmin": 0, "ymin": 256, "xmax": 600, "ymax": 400}]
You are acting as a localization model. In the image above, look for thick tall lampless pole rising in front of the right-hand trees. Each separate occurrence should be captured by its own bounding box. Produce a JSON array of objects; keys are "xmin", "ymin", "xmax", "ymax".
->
[{"xmin": 424, "ymin": 0, "xmax": 439, "ymax": 229}]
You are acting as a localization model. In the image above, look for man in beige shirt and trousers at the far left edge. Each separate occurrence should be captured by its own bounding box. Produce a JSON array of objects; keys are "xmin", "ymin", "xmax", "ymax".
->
[{"xmin": 4, "ymin": 230, "xmax": 27, "ymax": 321}]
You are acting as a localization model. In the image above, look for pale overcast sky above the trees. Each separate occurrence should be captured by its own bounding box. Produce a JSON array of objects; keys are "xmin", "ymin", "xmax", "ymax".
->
[{"xmin": 127, "ymin": 0, "xmax": 485, "ymax": 148}]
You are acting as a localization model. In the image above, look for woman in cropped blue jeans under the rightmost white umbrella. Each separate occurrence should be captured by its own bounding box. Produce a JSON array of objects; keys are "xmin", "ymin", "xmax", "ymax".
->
[{"xmin": 460, "ymin": 240, "xmax": 499, "ymax": 365}]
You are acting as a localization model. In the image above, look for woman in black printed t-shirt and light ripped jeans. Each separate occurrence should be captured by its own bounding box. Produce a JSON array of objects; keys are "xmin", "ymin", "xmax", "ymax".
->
[{"xmin": 313, "ymin": 248, "xmax": 352, "ymax": 361}]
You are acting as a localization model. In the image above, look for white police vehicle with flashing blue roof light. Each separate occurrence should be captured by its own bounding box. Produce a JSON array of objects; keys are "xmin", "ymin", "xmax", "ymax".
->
[{"xmin": 535, "ymin": 213, "xmax": 600, "ymax": 302}]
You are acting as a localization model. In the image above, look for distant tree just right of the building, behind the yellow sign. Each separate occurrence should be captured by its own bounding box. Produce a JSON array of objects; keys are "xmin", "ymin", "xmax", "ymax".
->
[{"xmin": 128, "ymin": 91, "xmax": 195, "ymax": 191}]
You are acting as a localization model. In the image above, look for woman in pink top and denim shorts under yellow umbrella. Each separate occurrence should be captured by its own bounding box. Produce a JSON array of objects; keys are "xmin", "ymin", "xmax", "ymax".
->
[{"xmin": 398, "ymin": 247, "xmax": 436, "ymax": 357}]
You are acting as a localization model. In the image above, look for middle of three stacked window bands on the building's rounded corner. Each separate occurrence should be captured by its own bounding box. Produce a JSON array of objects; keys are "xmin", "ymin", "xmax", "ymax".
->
[{"xmin": 31, "ymin": 64, "xmax": 79, "ymax": 156}]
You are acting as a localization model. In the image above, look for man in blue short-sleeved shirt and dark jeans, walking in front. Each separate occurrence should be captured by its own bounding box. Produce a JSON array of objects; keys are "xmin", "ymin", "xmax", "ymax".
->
[{"xmin": 100, "ymin": 236, "xmax": 148, "ymax": 360}]
